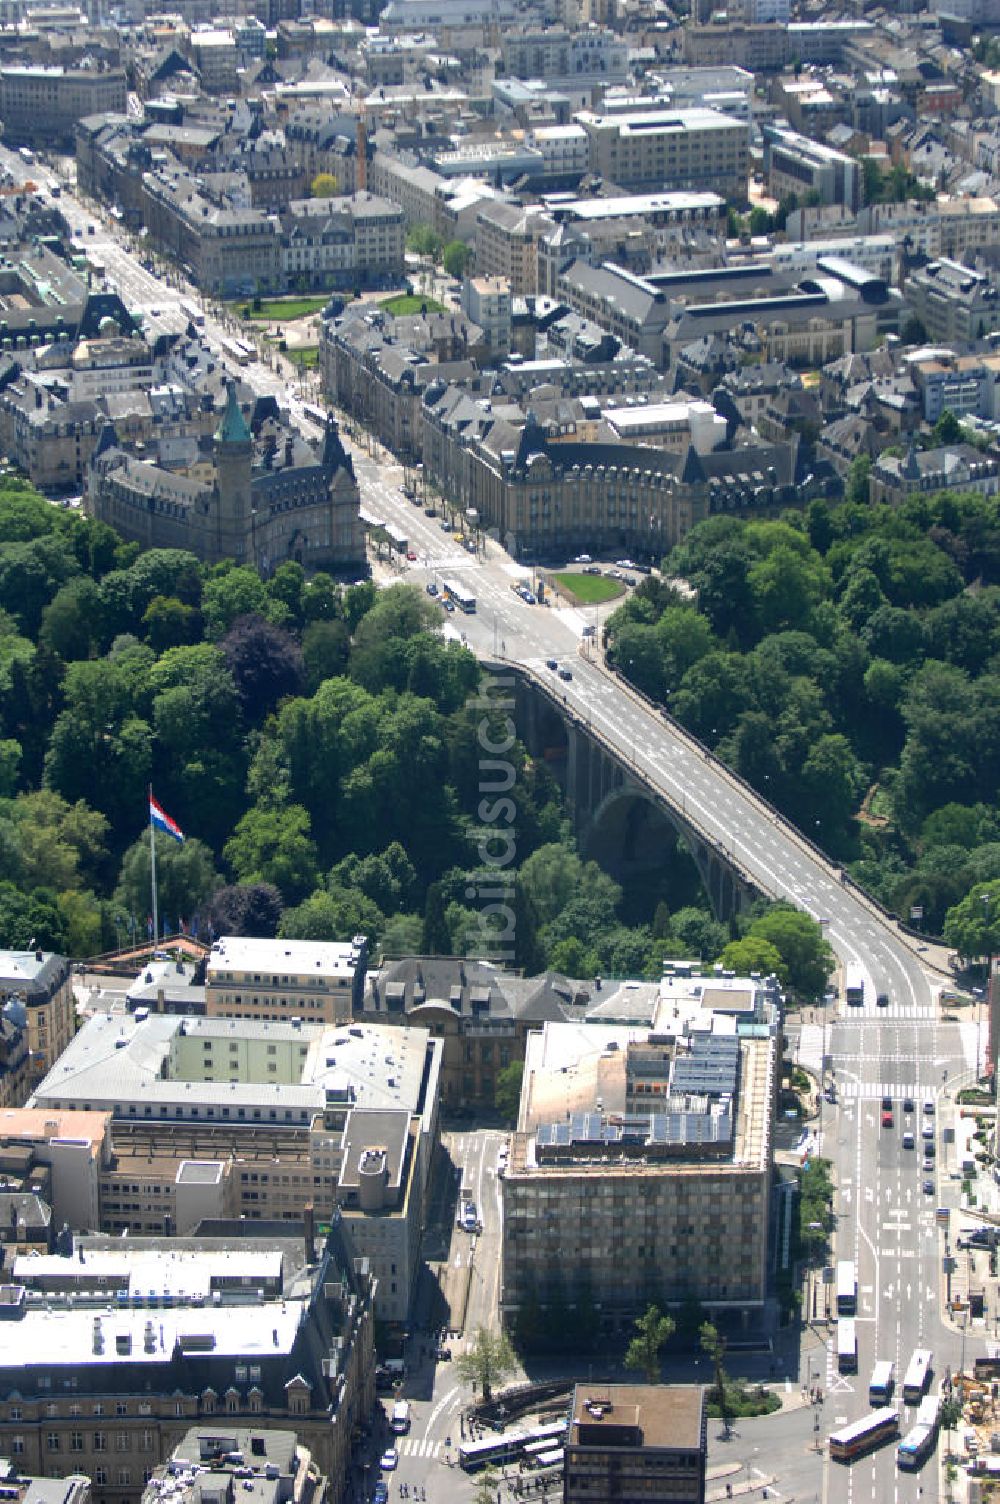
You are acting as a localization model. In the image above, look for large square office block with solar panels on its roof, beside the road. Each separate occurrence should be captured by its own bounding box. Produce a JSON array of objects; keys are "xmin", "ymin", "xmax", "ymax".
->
[{"xmin": 501, "ymin": 979, "xmax": 779, "ymax": 1330}]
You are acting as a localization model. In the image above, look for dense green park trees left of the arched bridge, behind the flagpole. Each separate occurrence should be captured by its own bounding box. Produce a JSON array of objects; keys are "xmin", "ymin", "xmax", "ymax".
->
[{"xmin": 0, "ymin": 478, "xmax": 829, "ymax": 1004}]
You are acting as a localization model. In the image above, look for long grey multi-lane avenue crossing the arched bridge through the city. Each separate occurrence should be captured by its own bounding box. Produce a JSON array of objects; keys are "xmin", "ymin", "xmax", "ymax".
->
[{"xmin": 13, "ymin": 146, "xmax": 977, "ymax": 1504}]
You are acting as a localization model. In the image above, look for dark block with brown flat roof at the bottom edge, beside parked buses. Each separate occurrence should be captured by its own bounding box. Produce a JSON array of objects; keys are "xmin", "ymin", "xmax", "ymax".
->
[{"xmin": 562, "ymin": 1382, "xmax": 708, "ymax": 1504}]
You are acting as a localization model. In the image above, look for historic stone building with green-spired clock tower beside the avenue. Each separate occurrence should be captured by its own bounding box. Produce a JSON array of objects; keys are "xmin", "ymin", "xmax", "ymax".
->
[{"xmin": 87, "ymin": 385, "xmax": 364, "ymax": 575}]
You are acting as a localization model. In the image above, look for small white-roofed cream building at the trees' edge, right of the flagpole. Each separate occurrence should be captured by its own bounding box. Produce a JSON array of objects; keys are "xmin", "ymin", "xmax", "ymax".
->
[{"xmin": 205, "ymin": 935, "xmax": 368, "ymax": 1024}]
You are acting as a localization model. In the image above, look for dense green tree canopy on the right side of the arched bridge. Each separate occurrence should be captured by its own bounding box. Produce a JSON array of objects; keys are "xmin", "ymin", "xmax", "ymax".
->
[{"xmin": 606, "ymin": 493, "xmax": 1000, "ymax": 938}]
